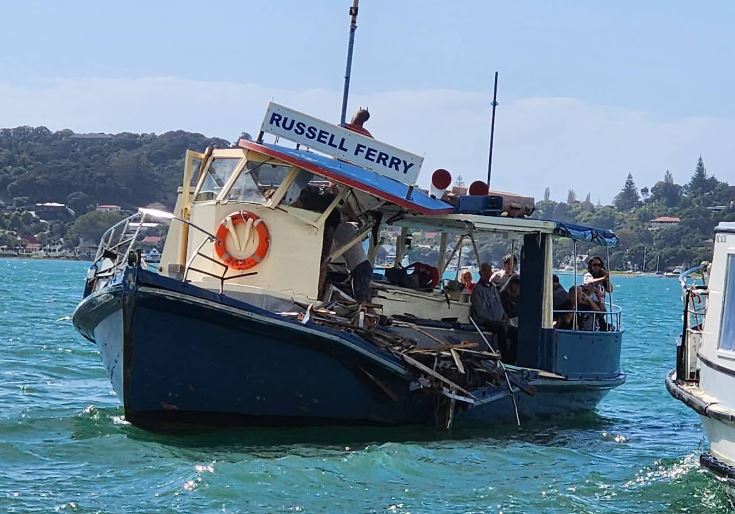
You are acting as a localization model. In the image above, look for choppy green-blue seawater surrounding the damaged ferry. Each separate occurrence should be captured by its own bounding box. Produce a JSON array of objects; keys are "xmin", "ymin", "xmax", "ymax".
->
[{"xmin": 0, "ymin": 259, "xmax": 732, "ymax": 514}]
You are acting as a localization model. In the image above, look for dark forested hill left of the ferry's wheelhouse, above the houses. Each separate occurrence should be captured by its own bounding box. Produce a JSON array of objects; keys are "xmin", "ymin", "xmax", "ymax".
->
[{"xmin": 0, "ymin": 127, "xmax": 229, "ymax": 208}]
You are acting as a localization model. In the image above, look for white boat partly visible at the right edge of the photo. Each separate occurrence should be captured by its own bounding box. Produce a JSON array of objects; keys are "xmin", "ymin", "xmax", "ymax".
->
[{"xmin": 666, "ymin": 222, "xmax": 735, "ymax": 482}]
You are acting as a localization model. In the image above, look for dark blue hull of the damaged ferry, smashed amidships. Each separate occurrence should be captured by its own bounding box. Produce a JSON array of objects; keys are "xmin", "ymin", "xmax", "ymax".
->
[{"xmin": 74, "ymin": 267, "xmax": 622, "ymax": 427}]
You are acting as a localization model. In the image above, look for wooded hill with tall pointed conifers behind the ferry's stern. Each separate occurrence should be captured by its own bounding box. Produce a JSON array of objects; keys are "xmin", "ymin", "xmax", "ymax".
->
[{"xmin": 534, "ymin": 156, "xmax": 735, "ymax": 271}]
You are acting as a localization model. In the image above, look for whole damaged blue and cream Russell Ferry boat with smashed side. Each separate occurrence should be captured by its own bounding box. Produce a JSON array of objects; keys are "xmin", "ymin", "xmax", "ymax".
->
[{"xmin": 73, "ymin": 103, "xmax": 625, "ymax": 427}]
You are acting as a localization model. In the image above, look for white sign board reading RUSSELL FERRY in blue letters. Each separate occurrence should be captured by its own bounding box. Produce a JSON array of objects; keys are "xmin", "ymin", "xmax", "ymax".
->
[{"xmin": 260, "ymin": 102, "xmax": 424, "ymax": 185}]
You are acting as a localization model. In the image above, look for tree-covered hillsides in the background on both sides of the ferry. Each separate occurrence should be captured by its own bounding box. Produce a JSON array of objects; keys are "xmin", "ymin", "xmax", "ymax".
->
[{"xmin": 0, "ymin": 127, "xmax": 735, "ymax": 271}]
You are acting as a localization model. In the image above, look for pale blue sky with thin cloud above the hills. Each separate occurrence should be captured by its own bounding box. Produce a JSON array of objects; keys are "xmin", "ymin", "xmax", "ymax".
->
[{"xmin": 0, "ymin": 0, "xmax": 735, "ymax": 203}]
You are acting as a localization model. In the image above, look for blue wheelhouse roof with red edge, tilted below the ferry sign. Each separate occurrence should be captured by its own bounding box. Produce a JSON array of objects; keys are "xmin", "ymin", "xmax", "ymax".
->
[{"xmin": 239, "ymin": 139, "xmax": 454, "ymax": 215}]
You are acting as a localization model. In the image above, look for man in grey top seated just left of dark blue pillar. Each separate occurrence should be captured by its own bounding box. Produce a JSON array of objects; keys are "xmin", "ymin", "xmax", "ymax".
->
[{"xmin": 470, "ymin": 262, "xmax": 518, "ymax": 363}]
